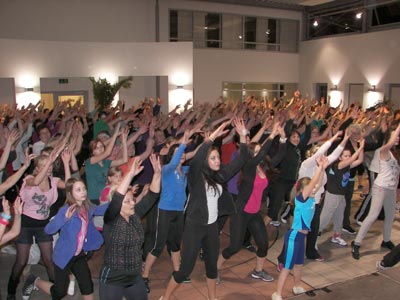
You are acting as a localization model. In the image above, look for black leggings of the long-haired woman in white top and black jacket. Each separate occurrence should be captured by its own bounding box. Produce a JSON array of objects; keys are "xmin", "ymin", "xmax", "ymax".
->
[{"xmin": 172, "ymin": 219, "xmax": 219, "ymax": 283}]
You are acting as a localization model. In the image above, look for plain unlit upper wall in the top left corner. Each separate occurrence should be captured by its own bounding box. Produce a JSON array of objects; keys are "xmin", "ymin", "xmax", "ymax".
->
[{"xmin": 0, "ymin": 0, "xmax": 156, "ymax": 42}]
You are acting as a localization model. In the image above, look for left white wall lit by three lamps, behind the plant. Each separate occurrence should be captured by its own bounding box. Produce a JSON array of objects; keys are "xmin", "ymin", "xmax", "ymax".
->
[{"xmin": 0, "ymin": 39, "xmax": 193, "ymax": 109}]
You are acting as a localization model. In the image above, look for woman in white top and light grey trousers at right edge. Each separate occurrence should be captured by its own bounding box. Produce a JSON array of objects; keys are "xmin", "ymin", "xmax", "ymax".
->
[{"xmin": 351, "ymin": 124, "xmax": 400, "ymax": 259}]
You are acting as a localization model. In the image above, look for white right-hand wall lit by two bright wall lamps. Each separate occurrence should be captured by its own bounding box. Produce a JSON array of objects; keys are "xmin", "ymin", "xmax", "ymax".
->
[{"xmin": 299, "ymin": 29, "xmax": 400, "ymax": 108}]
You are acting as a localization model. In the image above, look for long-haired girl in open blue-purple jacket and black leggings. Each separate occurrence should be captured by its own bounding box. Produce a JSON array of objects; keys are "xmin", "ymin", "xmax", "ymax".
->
[{"xmin": 22, "ymin": 178, "xmax": 108, "ymax": 300}]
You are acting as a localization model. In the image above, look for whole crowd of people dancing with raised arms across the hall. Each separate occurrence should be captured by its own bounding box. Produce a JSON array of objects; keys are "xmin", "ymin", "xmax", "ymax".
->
[{"xmin": 0, "ymin": 92, "xmax": 400, "ymax": 300}]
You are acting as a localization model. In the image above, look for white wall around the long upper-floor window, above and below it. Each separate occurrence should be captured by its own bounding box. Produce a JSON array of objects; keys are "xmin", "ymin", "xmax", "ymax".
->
[{"xmin": 160, "ymin": 0, "xmax": 301, "ymax": 102}]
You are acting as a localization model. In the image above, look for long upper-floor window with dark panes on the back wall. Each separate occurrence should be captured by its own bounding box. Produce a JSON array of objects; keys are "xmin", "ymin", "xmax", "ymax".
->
[{"xmin": 170, "ymin": 10, "xmax": 299, "ymax": 53}]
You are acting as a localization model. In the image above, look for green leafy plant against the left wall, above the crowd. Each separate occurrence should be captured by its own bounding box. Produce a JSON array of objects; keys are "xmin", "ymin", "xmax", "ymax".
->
[{"xmin": 89, "ymin": 76, "xmax": 133, "ymax": 110}]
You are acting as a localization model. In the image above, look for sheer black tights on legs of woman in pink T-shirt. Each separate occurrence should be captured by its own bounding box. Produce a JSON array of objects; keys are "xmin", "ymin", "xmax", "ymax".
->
[{"xmin": 7, "ymin": 242, "xmax": 54, "ymax": 295}]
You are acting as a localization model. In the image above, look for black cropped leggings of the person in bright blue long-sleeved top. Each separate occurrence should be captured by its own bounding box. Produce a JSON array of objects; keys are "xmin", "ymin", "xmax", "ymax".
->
[{"xmin": 151, "ymin": 209, "xmax": 184, "ymax": 257}]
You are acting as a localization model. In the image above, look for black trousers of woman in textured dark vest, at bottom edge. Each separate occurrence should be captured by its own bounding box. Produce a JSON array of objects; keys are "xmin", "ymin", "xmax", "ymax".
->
[{"xmin": 99, "ymin": 275, "xmax": 148, "ymax": 300}]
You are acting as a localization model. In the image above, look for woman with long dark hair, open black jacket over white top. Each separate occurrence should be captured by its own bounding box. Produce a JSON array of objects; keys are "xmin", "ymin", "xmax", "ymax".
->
[{"xmin": 160, "ymin": 119, "xmax": 248, "ymax": 300}]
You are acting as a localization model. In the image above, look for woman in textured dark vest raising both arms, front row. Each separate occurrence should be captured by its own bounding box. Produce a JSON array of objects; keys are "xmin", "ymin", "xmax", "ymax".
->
[{"xmin": 99, "ymin": 154, "xmax": 161, "ymax": 300}]
